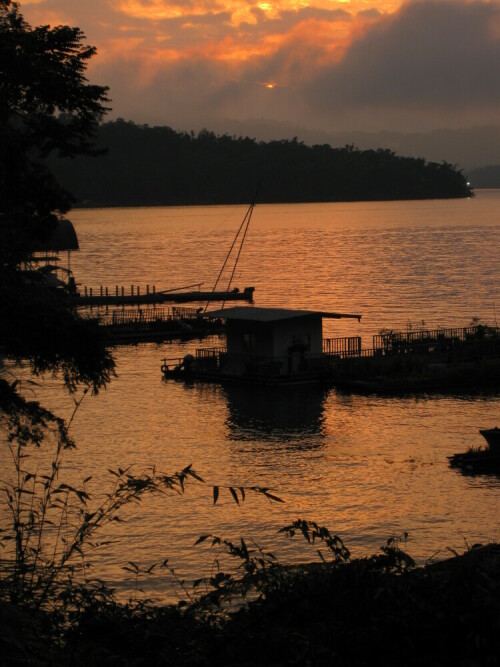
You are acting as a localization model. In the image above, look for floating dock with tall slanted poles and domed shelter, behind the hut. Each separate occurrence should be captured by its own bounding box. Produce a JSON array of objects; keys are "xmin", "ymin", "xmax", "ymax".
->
[{"xmin": 22, "ymin": 204, "xmax": 255, "ymax": 344}]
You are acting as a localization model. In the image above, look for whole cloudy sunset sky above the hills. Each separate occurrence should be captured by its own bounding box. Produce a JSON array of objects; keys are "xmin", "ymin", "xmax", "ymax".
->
[{"xmin": 20, "ymin": 0, "xmax": 500, "ymax": 142}]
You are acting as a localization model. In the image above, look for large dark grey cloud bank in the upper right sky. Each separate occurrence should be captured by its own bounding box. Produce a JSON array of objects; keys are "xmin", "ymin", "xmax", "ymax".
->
[{"xmin": 304, "ymin": 1, "xmax": 500, "ymax": 125}]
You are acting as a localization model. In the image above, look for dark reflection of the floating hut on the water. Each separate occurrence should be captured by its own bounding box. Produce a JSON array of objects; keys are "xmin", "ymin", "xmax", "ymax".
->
[{"xmin": 223, "ymin": 384, "xmax": 328, "ymax": 444}]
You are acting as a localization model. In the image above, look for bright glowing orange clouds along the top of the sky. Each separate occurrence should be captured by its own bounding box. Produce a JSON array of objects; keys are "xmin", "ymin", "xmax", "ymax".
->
[{"xmin": 23, "ymin": 0, "xmax": 402, "ymax": 69}]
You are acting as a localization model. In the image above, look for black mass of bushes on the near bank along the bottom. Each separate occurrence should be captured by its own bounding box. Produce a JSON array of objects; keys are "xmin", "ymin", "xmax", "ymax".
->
[{"xmin": 0, "ymin": 536, "xmax": 500, "ymax": 667}]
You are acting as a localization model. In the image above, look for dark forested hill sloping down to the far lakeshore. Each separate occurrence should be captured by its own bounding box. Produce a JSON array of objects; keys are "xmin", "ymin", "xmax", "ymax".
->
[{"xmin": 50, "ymin": 120, "xmax": 470, "ymax": 206}]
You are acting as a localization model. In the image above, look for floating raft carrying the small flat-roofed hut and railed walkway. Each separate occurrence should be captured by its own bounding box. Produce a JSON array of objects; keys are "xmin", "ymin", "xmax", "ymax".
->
[{"xmin": 162, "ymin": 307, "xmax": 500, "ymax": 386}]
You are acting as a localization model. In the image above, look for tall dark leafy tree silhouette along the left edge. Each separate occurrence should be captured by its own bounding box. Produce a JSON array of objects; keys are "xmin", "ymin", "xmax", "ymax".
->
[{"xmin": 0, "ymin": 0, "xmax": 113, "ymax": 415}]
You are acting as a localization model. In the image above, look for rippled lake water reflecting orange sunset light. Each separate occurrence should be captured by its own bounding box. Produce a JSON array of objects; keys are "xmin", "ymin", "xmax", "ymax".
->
[{"xmin": 3, "ymin": 191, "xmax": 500, "ymax": 600}]
